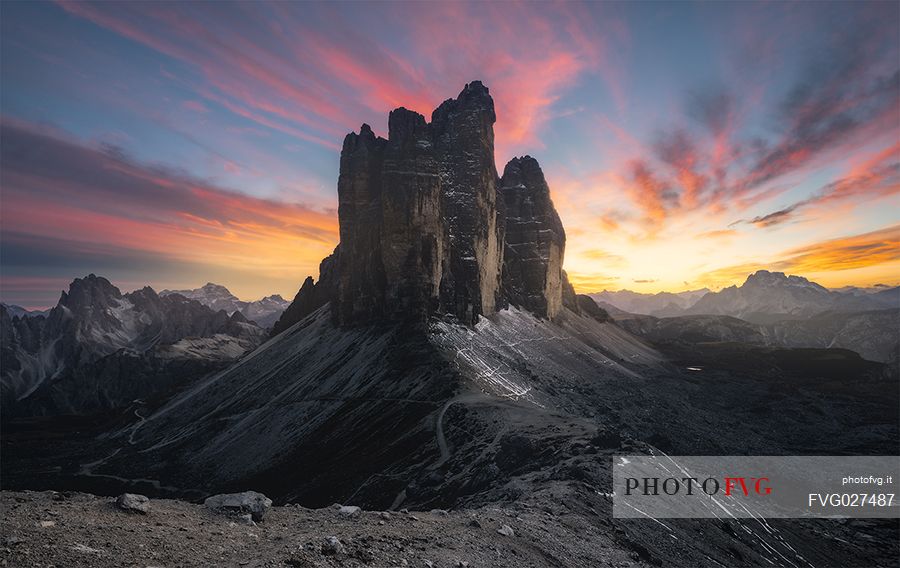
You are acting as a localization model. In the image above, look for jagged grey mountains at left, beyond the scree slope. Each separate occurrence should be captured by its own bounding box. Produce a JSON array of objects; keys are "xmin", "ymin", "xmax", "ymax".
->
[{"xmin": 0, "ymin": 274, "xmax": 265, "ymax": 414}]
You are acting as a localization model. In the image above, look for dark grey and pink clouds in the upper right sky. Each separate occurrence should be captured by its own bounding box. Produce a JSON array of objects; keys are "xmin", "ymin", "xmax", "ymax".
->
[{"xmin": 572, "ymin": 5, "xmax": 900, "ymax": 233}]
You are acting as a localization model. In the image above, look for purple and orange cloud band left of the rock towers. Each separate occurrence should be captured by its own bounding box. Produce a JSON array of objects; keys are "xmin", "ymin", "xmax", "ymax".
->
[{"xmin": 0, "ymin": 118, "xmax": 338, "ymax": 302}]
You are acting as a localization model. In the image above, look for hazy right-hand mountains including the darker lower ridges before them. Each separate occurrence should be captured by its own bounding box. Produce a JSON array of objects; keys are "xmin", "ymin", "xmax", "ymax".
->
[{"xmin": 591, "ymin": 270, "xmax": 900, "ymax": 363}]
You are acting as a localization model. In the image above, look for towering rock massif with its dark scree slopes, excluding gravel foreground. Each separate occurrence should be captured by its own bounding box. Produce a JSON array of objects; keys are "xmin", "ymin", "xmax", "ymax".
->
[{"xmin": 2, "ymin": 82, "xmax": 898, "ymax": 566}]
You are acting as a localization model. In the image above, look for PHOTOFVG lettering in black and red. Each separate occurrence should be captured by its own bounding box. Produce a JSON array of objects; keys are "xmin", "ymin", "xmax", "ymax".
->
[{"xmin": 625, "ymin": 476, "xmax": 772, "ymax": 497}]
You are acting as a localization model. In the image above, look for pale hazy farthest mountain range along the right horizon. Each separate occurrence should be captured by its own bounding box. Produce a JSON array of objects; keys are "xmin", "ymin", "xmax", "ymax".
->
[{"xmin": 591, "ymin": 270, "xmax": 900, "ymax": 324}]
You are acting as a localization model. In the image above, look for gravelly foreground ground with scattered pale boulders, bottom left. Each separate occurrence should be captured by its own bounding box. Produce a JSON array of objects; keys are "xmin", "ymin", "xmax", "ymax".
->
[{"xmin": 0, "ymin": 491, "xmax": 646, "ymax": 568}]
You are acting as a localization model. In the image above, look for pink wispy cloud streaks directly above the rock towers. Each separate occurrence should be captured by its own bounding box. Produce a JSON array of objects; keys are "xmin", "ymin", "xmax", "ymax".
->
[{"xmin": 60, "ymin": 0, "xmax": 628, "ymax": 162}]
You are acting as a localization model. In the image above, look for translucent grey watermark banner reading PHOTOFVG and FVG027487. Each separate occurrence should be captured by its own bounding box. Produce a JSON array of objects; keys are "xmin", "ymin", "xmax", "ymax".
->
[{"xmin": 611, "ymin": 455, "xmax": 900, "ymax": 519}]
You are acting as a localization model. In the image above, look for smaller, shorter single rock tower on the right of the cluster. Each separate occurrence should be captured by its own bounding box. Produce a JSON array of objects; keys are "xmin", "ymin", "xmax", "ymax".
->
[{"xmin": 500, "ymin": 156, "xmax": 566, "ymax": 318}]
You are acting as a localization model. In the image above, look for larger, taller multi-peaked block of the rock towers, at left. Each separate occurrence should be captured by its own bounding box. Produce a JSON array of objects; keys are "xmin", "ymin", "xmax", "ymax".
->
[{"xmin": 334, "ymin": 82, "xmax": 502, "ymax": 325}]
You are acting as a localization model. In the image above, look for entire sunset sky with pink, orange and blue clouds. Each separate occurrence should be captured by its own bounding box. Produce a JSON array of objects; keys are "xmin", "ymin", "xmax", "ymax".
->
[{"xmin": 0, "ymin": 2, "xmax": 900, "ymax": 308}]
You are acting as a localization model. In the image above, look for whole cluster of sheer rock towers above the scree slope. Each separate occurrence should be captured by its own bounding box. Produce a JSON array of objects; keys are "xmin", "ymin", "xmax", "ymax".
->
[{"xmin": 274, "ymin": 81, "xmax": 577, "ymax": 328}]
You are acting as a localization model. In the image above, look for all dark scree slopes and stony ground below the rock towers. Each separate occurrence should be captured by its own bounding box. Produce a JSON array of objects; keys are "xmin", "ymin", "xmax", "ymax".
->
[{"xmin": 2, "ymin": 309, "xmax": 900, "ymax": 567}]
